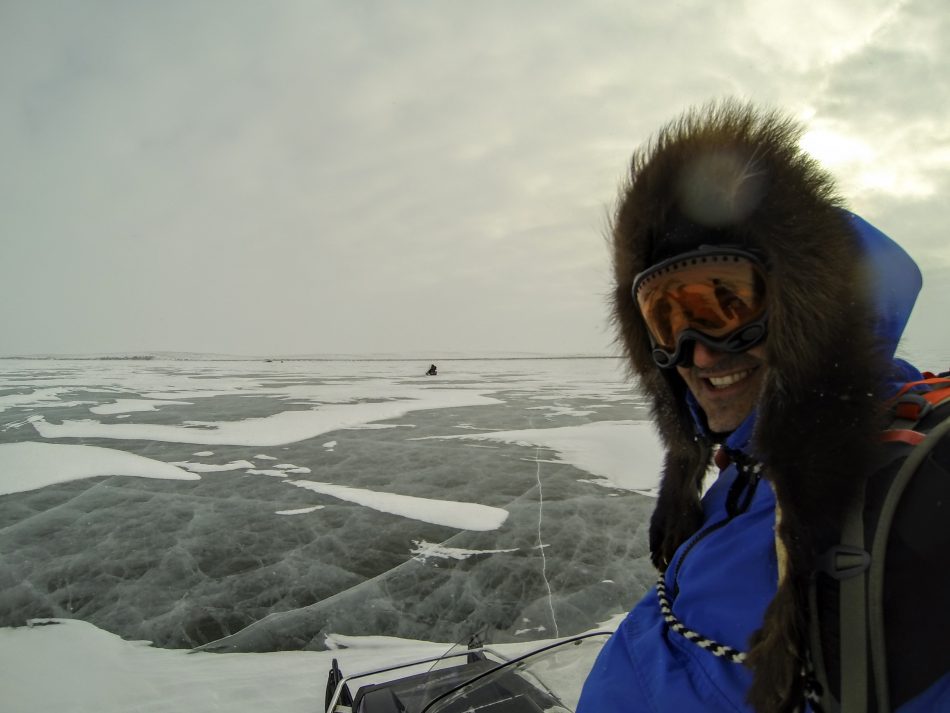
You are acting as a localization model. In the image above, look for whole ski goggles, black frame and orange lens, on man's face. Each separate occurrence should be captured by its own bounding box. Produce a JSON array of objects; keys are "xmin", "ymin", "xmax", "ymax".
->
[{"xmin": 633, "ymin": 247, "xmax": 766, "ymax": 369}]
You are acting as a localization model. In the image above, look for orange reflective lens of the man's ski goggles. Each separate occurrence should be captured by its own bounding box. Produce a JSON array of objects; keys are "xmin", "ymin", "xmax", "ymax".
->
[{"xmin": 633, "ymin": 251, "xmax": 765, "ymax": 352}]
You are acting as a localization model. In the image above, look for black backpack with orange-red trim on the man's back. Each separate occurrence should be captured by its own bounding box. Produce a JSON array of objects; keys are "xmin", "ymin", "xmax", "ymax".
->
[{"xmin": 806, "ymin": 372, "xmax": 950, "ymax": 713}]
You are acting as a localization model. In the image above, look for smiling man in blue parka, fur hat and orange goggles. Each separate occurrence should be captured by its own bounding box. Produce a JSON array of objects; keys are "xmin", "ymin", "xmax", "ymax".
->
[{"xmin": 578, "ymin": 102, "xmax": 950, "ymax": 713}]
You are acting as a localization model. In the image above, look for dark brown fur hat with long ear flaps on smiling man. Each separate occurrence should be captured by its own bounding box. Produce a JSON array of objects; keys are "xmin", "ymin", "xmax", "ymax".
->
[{"xmin": 612, "ymin": 101, "xmax": 889, "ymax": 711}]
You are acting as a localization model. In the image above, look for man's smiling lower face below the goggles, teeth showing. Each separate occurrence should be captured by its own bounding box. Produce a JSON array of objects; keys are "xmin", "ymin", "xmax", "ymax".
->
[{"xmin": 676, "ymin": 342, "xmax": 767, "ymax": 433}]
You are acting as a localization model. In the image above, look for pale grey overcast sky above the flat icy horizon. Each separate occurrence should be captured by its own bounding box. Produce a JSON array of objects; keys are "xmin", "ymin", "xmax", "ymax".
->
[{"xmin": 0, "ymin": 0, "xmax": 950, "ymax": 368}]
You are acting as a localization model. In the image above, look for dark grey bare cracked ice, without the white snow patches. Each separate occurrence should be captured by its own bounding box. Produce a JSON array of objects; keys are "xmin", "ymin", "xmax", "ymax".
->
[{"xmin": 0, "ymin": 360, "xmax": 654, "ymax": 651}]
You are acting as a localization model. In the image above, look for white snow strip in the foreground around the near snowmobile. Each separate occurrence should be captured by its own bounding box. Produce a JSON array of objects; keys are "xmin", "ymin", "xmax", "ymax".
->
[{"xmin": 0, "ymin": 620, "xmax": 619, "ymax": 713}]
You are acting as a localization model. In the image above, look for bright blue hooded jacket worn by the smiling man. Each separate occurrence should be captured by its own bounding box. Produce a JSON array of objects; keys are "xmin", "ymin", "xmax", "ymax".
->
[{"xmin": 577, "ymin": 215, "xmax": 950, "ymax": 713}]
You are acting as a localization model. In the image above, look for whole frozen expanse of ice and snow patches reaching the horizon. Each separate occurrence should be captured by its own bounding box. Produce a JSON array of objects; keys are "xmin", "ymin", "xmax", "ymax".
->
[{"xmin": 0, "ymin": 359, "xmax": 660, "ymax": 651}]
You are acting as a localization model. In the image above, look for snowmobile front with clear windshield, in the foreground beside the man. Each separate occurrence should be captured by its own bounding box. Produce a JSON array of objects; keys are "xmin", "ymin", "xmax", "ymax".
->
[{"xmin": 325, "ymin": 631, "xmax": 610, "ymax": 713}]
